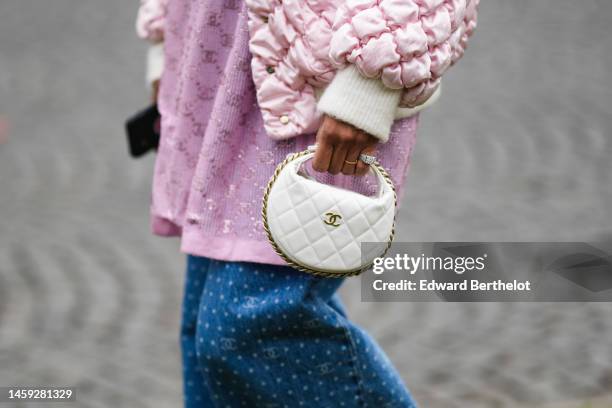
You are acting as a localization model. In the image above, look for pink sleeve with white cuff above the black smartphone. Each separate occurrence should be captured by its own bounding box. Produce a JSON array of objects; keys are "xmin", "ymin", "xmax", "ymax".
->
[{"xmin": 136, "ymin": 0, "xmax": 168, "ymax": 84}]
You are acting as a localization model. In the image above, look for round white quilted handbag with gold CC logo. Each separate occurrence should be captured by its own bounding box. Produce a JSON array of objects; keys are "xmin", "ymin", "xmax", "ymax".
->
[{"xmin": 262, "ymin": 150, "xmax": 397, "ymax": 277}]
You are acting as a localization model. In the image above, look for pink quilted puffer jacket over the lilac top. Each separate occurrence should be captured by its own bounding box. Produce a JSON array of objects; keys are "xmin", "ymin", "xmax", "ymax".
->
[{"xmin": 138, "ymin": 0, "xmax": 480, "ymax": 142}]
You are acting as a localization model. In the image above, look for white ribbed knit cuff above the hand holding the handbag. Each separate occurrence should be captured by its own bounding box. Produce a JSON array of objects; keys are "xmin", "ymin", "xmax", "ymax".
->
[{"xmin": 317, "ymin": 65, "xmax": 401, "ymax": 143}]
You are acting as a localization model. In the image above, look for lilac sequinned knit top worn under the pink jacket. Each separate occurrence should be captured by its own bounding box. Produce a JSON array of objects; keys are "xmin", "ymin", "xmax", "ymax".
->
[{"xmin": 151, "ymin": 0, "xmax": 418, "ymax": 265}]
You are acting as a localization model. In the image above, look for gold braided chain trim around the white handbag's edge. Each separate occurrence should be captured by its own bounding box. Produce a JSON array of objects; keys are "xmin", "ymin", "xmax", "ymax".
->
[{"xmin": 261, "ymin": 150, "xmax": 397, "ymax": 278}]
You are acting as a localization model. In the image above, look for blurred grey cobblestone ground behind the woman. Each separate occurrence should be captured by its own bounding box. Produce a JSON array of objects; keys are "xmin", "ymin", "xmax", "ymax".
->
[{"xmin": 0, "ymin": 0, "xmax": 612, "ymax": 408}]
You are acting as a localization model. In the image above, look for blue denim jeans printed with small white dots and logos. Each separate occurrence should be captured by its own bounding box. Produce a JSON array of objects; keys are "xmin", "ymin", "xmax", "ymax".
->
[{"xmin": 181, "ymin": 256, "xmax": 415, "ymax": 408}]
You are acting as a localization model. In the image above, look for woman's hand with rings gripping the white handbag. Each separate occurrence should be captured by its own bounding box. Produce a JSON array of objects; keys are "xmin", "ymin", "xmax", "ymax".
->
[{"xmin": 312, "ymin": 115, "xmax": 378, "ymax": 176}]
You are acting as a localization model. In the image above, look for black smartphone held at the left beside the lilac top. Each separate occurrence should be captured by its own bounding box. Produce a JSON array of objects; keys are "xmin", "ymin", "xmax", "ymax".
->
[{"xmin": 125, "ymin": 105, "xmax": 161, "ymax": 157}]
